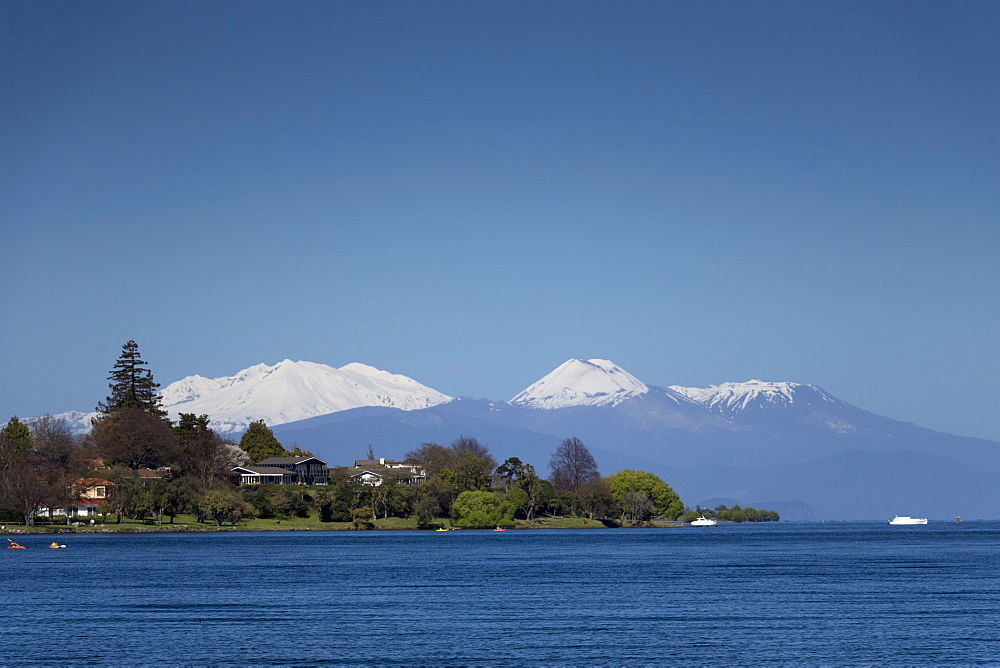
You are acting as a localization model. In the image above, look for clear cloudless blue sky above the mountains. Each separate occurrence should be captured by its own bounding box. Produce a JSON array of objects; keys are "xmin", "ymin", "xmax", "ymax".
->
[{"xmin": 0, "ymin": 0, "xmax": 1000, "ymax": 440}]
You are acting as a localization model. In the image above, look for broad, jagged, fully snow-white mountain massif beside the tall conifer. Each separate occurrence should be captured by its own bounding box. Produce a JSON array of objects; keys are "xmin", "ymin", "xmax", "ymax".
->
[{"xmin": 162, "ymin": 360, "xmax": 451, "ymax": 433}]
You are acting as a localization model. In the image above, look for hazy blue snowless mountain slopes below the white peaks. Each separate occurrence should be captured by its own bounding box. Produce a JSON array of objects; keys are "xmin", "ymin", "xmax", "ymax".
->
[{"xmin": 274, "ymin": 392, "xmax": 1000, "ymax": 519}]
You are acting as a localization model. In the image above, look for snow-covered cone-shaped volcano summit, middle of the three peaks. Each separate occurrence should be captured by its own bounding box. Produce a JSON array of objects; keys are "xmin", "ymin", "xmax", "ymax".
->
[{"xmin": 510, "ymin": 359, "xmax": 649, "ymax": 410}]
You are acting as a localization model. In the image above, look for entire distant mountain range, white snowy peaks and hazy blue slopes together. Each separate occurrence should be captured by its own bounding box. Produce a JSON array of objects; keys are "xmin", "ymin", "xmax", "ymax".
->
[{"xmin": 43, "ymin": 359, "xmax": 1000, "ymax": 519}]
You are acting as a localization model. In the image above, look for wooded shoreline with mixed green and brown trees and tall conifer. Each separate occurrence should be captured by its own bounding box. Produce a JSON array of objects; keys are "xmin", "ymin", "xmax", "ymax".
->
[{"xmin": 0, "ymin": 341, "xmax": 779, "ymax": 532}]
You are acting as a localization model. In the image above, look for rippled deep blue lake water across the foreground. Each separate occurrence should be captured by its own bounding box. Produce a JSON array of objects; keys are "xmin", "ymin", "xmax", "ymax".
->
[{"xmin": 0, "ymin": 522, "xmax": 1000, "ymax": 665}]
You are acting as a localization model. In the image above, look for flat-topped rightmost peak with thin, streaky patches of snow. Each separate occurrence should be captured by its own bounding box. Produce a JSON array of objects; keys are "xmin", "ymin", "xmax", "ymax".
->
[{"xmin": 670, "ymin": 380, "xmax": 837, "ymax": 418}]
